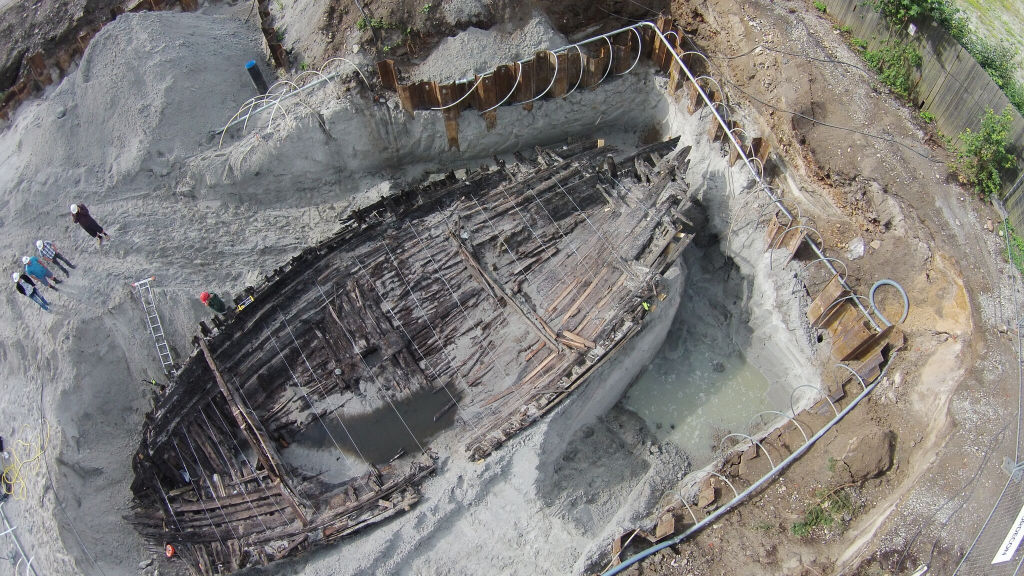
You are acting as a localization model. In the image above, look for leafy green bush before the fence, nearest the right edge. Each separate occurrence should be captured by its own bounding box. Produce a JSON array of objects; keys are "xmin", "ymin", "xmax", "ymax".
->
[{"xmin": 950, "ymin": 108, "xmax": 1017, "ymax": 198}]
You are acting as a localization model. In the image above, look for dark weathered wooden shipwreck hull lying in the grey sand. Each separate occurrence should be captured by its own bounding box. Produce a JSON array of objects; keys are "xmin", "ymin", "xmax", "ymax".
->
[{"xmin": 130, "ymin": 139, "xmax": 692, "ymax": 574}]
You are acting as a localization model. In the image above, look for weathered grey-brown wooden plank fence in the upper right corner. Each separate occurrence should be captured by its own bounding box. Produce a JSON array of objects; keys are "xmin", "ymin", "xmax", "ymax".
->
[{"xmin": 824, "ymin": 0, "xmax": 1024, "ymax": 224}]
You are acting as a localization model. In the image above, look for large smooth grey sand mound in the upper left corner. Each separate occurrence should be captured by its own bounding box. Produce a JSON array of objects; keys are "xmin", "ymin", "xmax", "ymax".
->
[{"xmin": 15, "ymin": 12, "xmax": 263, "ymax": 186}]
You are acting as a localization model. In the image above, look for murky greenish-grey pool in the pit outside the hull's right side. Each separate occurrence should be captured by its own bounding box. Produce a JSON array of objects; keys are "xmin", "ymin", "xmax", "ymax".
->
[{"xmin": 623, "ymin": 237, "xmax": 771, "ymax": 464}]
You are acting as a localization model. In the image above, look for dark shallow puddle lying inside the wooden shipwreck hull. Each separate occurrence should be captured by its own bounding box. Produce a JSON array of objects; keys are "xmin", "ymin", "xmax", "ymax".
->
[{"xmin": 282, "ymin": 390, "xmax": 456, "ymax": 475}]
